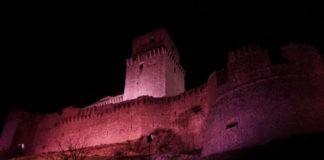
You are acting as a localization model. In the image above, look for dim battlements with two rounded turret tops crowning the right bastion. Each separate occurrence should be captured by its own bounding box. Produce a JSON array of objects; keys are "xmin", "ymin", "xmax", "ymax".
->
[{"xmin": 210, "ymin": 44, "xmax": 323, "ymax": 86}]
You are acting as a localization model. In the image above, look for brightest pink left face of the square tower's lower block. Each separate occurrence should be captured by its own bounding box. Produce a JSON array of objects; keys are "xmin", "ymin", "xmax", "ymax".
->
[{"xmin": 124, "ymin": 48, "xmax": 166, "ymax": 100}]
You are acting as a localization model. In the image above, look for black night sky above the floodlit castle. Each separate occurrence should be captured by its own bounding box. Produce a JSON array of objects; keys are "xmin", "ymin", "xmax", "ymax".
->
[{"xmin": 0, "ymin": 1, "xmax": 324, "ymax": 126}]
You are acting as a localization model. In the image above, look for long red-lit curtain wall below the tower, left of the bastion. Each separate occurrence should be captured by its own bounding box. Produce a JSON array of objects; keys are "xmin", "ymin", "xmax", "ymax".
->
[{"xmin": 1, "ymin": 86, "xmax": 206, "ymax": 154}]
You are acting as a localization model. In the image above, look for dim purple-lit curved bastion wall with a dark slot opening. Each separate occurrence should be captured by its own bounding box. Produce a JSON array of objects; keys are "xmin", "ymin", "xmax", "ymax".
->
[{"xmin": 203, "ymin": 45, "xmax": 324, "ymax": 156}]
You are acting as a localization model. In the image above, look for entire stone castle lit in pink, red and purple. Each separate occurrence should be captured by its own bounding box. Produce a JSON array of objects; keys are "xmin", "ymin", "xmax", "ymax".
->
[{"xmin": 0, "ymin": 28, "xmax": 324, "ymax": 157}]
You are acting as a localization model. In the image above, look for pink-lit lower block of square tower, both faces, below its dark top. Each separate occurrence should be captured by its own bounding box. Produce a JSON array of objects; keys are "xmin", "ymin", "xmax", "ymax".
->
[{"xmin": 123, "ymin": 47, "xmax": 184, "ymax": 100}]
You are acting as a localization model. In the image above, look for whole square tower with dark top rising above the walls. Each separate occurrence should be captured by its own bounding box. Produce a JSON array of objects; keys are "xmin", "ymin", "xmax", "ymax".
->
[{"xmin": 123, "ymin": 28, "xmax": 185, "ymax": 100}]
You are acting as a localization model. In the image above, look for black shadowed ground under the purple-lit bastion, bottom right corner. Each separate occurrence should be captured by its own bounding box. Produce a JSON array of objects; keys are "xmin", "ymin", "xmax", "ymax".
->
[{"xmin": 204, "ymin": 133, "xmax": 324, "ymax": 160}]
